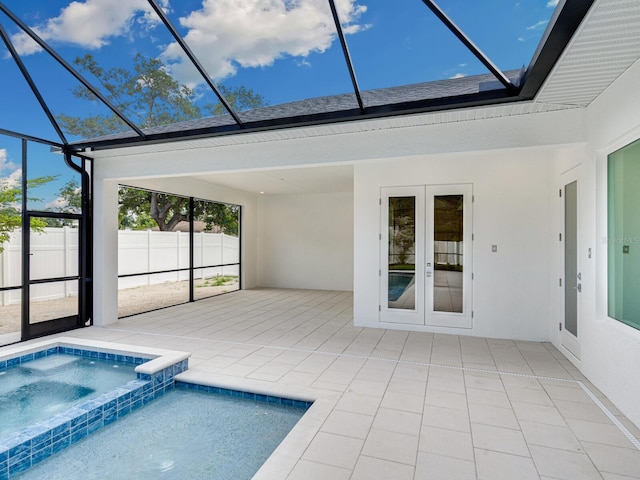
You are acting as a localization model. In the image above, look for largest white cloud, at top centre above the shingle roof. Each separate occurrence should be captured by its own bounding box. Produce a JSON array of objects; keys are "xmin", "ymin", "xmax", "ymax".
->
[{"xmin": 161, "ymin": 0, "xmax": 367, "ymax": 84}]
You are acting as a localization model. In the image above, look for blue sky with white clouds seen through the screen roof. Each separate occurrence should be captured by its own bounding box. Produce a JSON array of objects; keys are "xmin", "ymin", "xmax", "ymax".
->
[{"xmin": 0, "ymin": 0, "xmax": 557, "ymax": 207}]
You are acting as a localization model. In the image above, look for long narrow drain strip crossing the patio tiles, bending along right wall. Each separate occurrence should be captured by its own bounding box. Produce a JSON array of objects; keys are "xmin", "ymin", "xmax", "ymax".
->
[{"xmin": 109, "ymin": 328, "xmax": 640, "ymax": 450}]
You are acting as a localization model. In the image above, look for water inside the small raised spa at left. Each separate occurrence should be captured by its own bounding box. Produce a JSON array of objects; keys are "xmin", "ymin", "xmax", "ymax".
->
[{"xmin": 0, "ymin": 353, "xmax": 136, "ymax": 438}]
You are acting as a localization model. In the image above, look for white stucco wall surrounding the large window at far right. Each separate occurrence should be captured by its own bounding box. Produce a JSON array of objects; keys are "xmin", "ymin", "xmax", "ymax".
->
[{"xmin": 554, "ymin": 57, "xmax": 640, "ymax": 425}]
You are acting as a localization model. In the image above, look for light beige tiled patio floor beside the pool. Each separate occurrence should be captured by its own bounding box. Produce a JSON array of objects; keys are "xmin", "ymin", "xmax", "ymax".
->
[{"xmin": 38, "ymin": 289, "xmax": 640, "ymax": 480}]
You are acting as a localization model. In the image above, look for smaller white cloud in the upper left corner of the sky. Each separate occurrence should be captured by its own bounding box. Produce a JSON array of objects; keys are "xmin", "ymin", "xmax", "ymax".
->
[{"xmin": 12, "ymin": 0, "xmax": 168, "ymax": 55}]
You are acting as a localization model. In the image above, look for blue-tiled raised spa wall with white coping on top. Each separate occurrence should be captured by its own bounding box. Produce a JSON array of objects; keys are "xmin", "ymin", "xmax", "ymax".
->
[{"xmin": 0, "ymin": 337, "xmax": 191, "ymax": 480}]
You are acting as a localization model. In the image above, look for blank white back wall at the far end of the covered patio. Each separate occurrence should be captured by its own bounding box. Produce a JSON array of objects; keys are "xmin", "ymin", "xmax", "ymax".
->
[{"xmin": 258, "ymin": 193, "xmax": 353, "ymax": 290}]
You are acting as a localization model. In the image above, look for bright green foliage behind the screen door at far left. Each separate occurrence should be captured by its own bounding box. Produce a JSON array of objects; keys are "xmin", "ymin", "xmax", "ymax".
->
[{"xmin": 0, "ymin": 176, "xmax": 56, "ymax": 253}]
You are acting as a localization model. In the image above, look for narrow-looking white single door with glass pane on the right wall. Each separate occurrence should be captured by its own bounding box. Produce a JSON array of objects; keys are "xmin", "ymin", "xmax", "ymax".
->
[{"xmin": 559, "ymin": 167, "xmax": 582, "ymax": 358}]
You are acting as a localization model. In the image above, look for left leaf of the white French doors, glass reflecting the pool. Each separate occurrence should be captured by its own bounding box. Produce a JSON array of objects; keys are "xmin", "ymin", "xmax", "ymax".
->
[{"xmin": 379, "ymin": 187, "xmax": 424, "ymax": 325}]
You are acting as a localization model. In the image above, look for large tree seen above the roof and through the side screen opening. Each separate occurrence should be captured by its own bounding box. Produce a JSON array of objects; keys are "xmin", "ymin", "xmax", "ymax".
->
[{"xmin": 57, "ymin": 54, "xmax": 266, "ymax": 234}]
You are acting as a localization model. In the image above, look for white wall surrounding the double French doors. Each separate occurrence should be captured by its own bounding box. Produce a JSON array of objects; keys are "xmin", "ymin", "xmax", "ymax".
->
[{"xmin": 354, "ymin": 148, "xmax": 555, "ymax": 340}]
